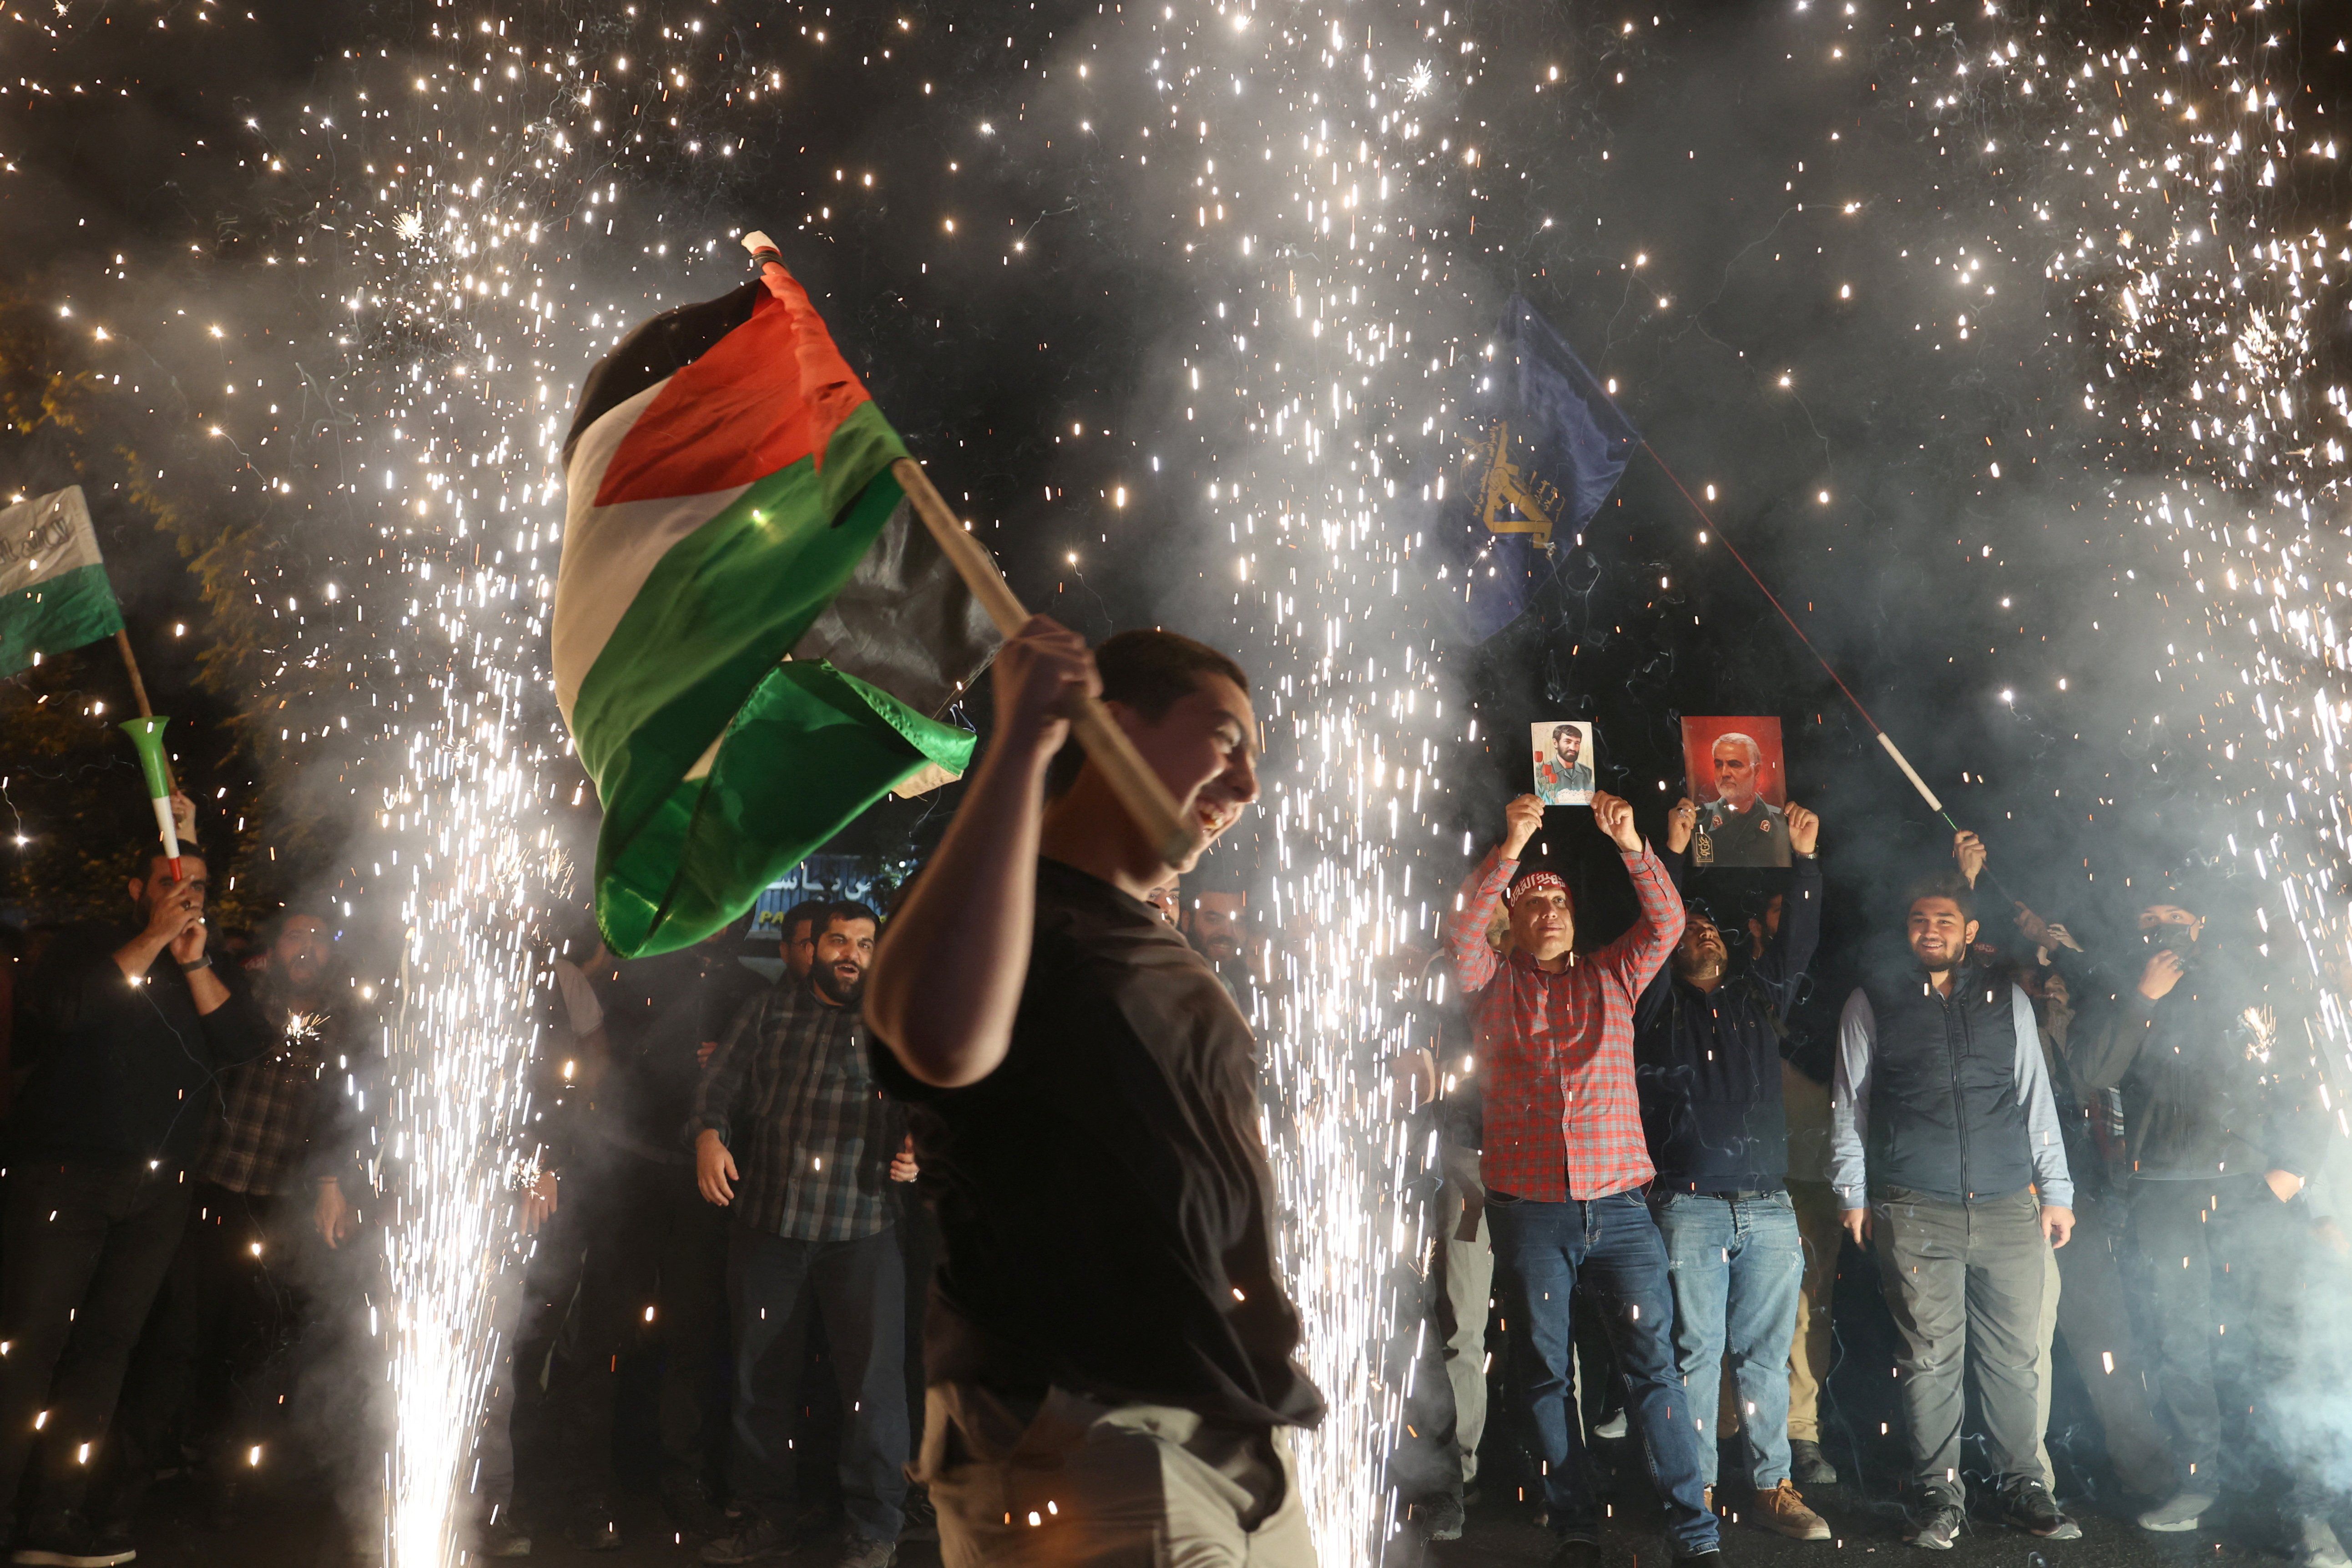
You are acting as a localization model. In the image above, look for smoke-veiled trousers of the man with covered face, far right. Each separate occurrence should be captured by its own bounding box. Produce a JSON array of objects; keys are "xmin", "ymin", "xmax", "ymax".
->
[{"xmin": 2131, "ymin": 1175, "xmax": 2305, "ymax": 1486}]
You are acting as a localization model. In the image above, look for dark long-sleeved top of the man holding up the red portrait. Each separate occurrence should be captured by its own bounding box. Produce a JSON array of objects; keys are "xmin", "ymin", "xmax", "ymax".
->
[{"xmin": 1632, "ymin": 853, "xmax": 1821, "ymax": 1192}]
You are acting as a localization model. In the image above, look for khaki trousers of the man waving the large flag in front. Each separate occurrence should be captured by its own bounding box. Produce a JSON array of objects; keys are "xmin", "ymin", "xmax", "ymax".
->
[{"xmin": 915, "ymin": 1382, "xmax": 1315, "ymax": 1568}]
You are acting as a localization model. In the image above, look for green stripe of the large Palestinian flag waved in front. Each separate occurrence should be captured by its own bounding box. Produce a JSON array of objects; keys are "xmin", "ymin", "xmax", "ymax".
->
[{"xmin": 571, "ymin": 402, "xmax": 971, "ymax": 957}]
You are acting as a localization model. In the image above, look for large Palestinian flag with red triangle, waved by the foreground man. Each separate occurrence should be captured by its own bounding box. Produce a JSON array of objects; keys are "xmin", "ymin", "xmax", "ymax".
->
[{"xmin": 553, "ymin": 268, "xmax": 997, "ymax": 957}]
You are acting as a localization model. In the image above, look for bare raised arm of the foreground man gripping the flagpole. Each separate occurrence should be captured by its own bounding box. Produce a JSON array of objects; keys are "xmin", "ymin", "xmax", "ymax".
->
[{"xmin": 866, "ymin": 616, "xmax": 1101, "ymax": 1089}]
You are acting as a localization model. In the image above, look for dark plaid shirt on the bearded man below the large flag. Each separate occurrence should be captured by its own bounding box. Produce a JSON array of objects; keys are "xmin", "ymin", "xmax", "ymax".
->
[{"xmin": 689, "ymin": 976, "xmax": 898, "ymax": 1241}]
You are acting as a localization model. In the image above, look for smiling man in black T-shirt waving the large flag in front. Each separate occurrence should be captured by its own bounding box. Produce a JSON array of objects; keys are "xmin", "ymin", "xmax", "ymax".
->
[{"xmin": 866, "ymin": 616, "xmax": 1322, "ymax": 1568}]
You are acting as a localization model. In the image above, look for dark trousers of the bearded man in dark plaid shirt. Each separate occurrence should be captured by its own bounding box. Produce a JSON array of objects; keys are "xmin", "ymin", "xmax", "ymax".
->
[{"xmin": 727, "ymin": 1225, "xmax": 910, "ymax": 1542}]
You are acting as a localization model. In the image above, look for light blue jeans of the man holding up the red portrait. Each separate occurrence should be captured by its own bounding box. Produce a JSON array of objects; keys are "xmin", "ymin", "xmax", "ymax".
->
[{"xmin": 1649, "ymin": 1192, "xmax": 1804, "ymax": 1493}]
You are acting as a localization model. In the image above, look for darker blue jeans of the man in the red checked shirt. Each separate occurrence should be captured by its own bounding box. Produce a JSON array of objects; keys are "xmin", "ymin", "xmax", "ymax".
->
[{"xmin": 1486, "ymin": 1192, "xmax": 1717, "ymax": 1556}]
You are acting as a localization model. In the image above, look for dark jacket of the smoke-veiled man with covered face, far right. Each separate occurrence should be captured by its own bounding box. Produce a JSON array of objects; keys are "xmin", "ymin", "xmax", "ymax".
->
[{"xmin": 2072, "ymin": 954, "xmax": 2328, "ymax": 1180}]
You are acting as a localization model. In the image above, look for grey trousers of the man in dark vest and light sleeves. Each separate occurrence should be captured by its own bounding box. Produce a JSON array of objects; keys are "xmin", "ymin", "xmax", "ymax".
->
[{"xmin": 1870, "ymin": 1187, "xmax": 2049, "ymax": 1507}]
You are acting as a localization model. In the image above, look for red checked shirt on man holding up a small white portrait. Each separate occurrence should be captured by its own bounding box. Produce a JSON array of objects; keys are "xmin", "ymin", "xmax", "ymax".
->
[{"xmin": 1447, "ymin": 846, "xmax": 1682, "ymax": 1204}]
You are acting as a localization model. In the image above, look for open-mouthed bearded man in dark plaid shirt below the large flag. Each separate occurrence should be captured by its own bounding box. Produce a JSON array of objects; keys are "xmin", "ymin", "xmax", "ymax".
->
[{"xmin": 691, "ymin": 902, "xmax": 915, "ymax": 1568}]
